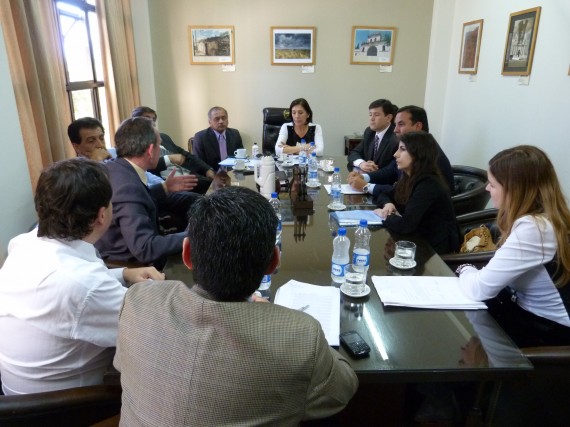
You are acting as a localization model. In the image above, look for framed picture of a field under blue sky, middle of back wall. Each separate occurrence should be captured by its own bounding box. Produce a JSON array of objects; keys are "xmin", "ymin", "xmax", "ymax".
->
[{"xmin": 270, "ymin": 27, "xmax": 317, "ymax": 65}]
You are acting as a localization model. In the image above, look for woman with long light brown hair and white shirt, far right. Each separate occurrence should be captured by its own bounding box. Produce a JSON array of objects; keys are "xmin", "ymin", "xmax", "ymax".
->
[{"xmin": 456, "ymin": 145, "xmax": 570, "ymax": 347}]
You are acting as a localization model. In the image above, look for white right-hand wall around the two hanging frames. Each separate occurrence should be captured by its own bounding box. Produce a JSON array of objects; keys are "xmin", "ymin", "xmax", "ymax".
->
[{"xmin": 425, "ymin": 0, "xmax": 570, "ymax": 196}]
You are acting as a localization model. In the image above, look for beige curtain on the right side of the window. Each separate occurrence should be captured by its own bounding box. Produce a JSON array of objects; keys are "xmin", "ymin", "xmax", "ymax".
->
[{"xmin": 96, "ymin": 0, "xmax": 140, "ymax": 135}]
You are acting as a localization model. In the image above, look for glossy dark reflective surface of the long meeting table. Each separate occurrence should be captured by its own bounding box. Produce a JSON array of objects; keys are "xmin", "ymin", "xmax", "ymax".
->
[{"xmin": 165, "ymin": 158, "xmax": 532, "ymax": 382}]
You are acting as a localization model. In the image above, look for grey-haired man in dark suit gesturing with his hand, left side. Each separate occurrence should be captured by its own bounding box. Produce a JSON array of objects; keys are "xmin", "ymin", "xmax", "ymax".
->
[{"xmin": 96, "ymin": 117, "xmax": 201, "ymax": 269}]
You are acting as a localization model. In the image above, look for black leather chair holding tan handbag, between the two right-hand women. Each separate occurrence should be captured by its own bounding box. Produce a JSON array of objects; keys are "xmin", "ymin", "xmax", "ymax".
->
[{"xmin": 441, "ymin": 208, "xmax": 499, "ymax": 271}]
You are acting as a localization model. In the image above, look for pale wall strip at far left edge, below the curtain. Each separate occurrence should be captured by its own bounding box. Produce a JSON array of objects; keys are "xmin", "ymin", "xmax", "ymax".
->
[{"xmin": 0, "ymin": 23, "xmax": 35, "ymax": 265}]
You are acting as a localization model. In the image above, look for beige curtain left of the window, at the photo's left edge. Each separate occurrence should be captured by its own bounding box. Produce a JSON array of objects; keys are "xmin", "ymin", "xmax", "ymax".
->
[{"xmin": 0, "ymin": 0, "xmax": 74, "ymax": 190}]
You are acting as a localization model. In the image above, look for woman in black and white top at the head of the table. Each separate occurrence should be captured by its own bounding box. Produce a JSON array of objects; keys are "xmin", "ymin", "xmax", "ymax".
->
[{"xmin": 275, "ymin": 98, "xmax": 324, "ymax": 156}]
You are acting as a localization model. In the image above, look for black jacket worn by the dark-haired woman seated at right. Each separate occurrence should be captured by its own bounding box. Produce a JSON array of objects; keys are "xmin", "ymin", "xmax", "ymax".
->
[{"xmin": 377, "ymin": 175, "xmax": 459, "ymax": 254}]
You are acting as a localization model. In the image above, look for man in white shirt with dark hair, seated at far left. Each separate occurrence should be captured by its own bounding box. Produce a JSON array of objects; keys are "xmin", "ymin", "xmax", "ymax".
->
[{"xmin": 0, "ymin": 158, "xmax": 164, "ymax": 394}]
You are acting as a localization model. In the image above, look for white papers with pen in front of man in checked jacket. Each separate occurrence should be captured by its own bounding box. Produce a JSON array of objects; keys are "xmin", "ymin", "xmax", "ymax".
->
[{"xmin": 275, "ymin": 280, "xmax": 340, "ymax": 346}]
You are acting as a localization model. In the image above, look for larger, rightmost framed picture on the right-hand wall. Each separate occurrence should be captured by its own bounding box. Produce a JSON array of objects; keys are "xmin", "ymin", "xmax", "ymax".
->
[{"xmin": 501, "ymin": 7, "xmax": 541, "ymax": 76}]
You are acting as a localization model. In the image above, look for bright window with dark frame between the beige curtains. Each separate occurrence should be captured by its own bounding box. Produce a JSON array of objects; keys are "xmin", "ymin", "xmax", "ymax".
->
[{"xmin": 55, "ymin": 0, "xmax": 109, "ymax": 143}]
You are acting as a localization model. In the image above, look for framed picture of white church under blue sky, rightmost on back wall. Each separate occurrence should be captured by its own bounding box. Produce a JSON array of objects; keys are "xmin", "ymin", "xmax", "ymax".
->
[{"xmin": 350, "ymin": 26, "xmax": 396, "ymax": 65}]
